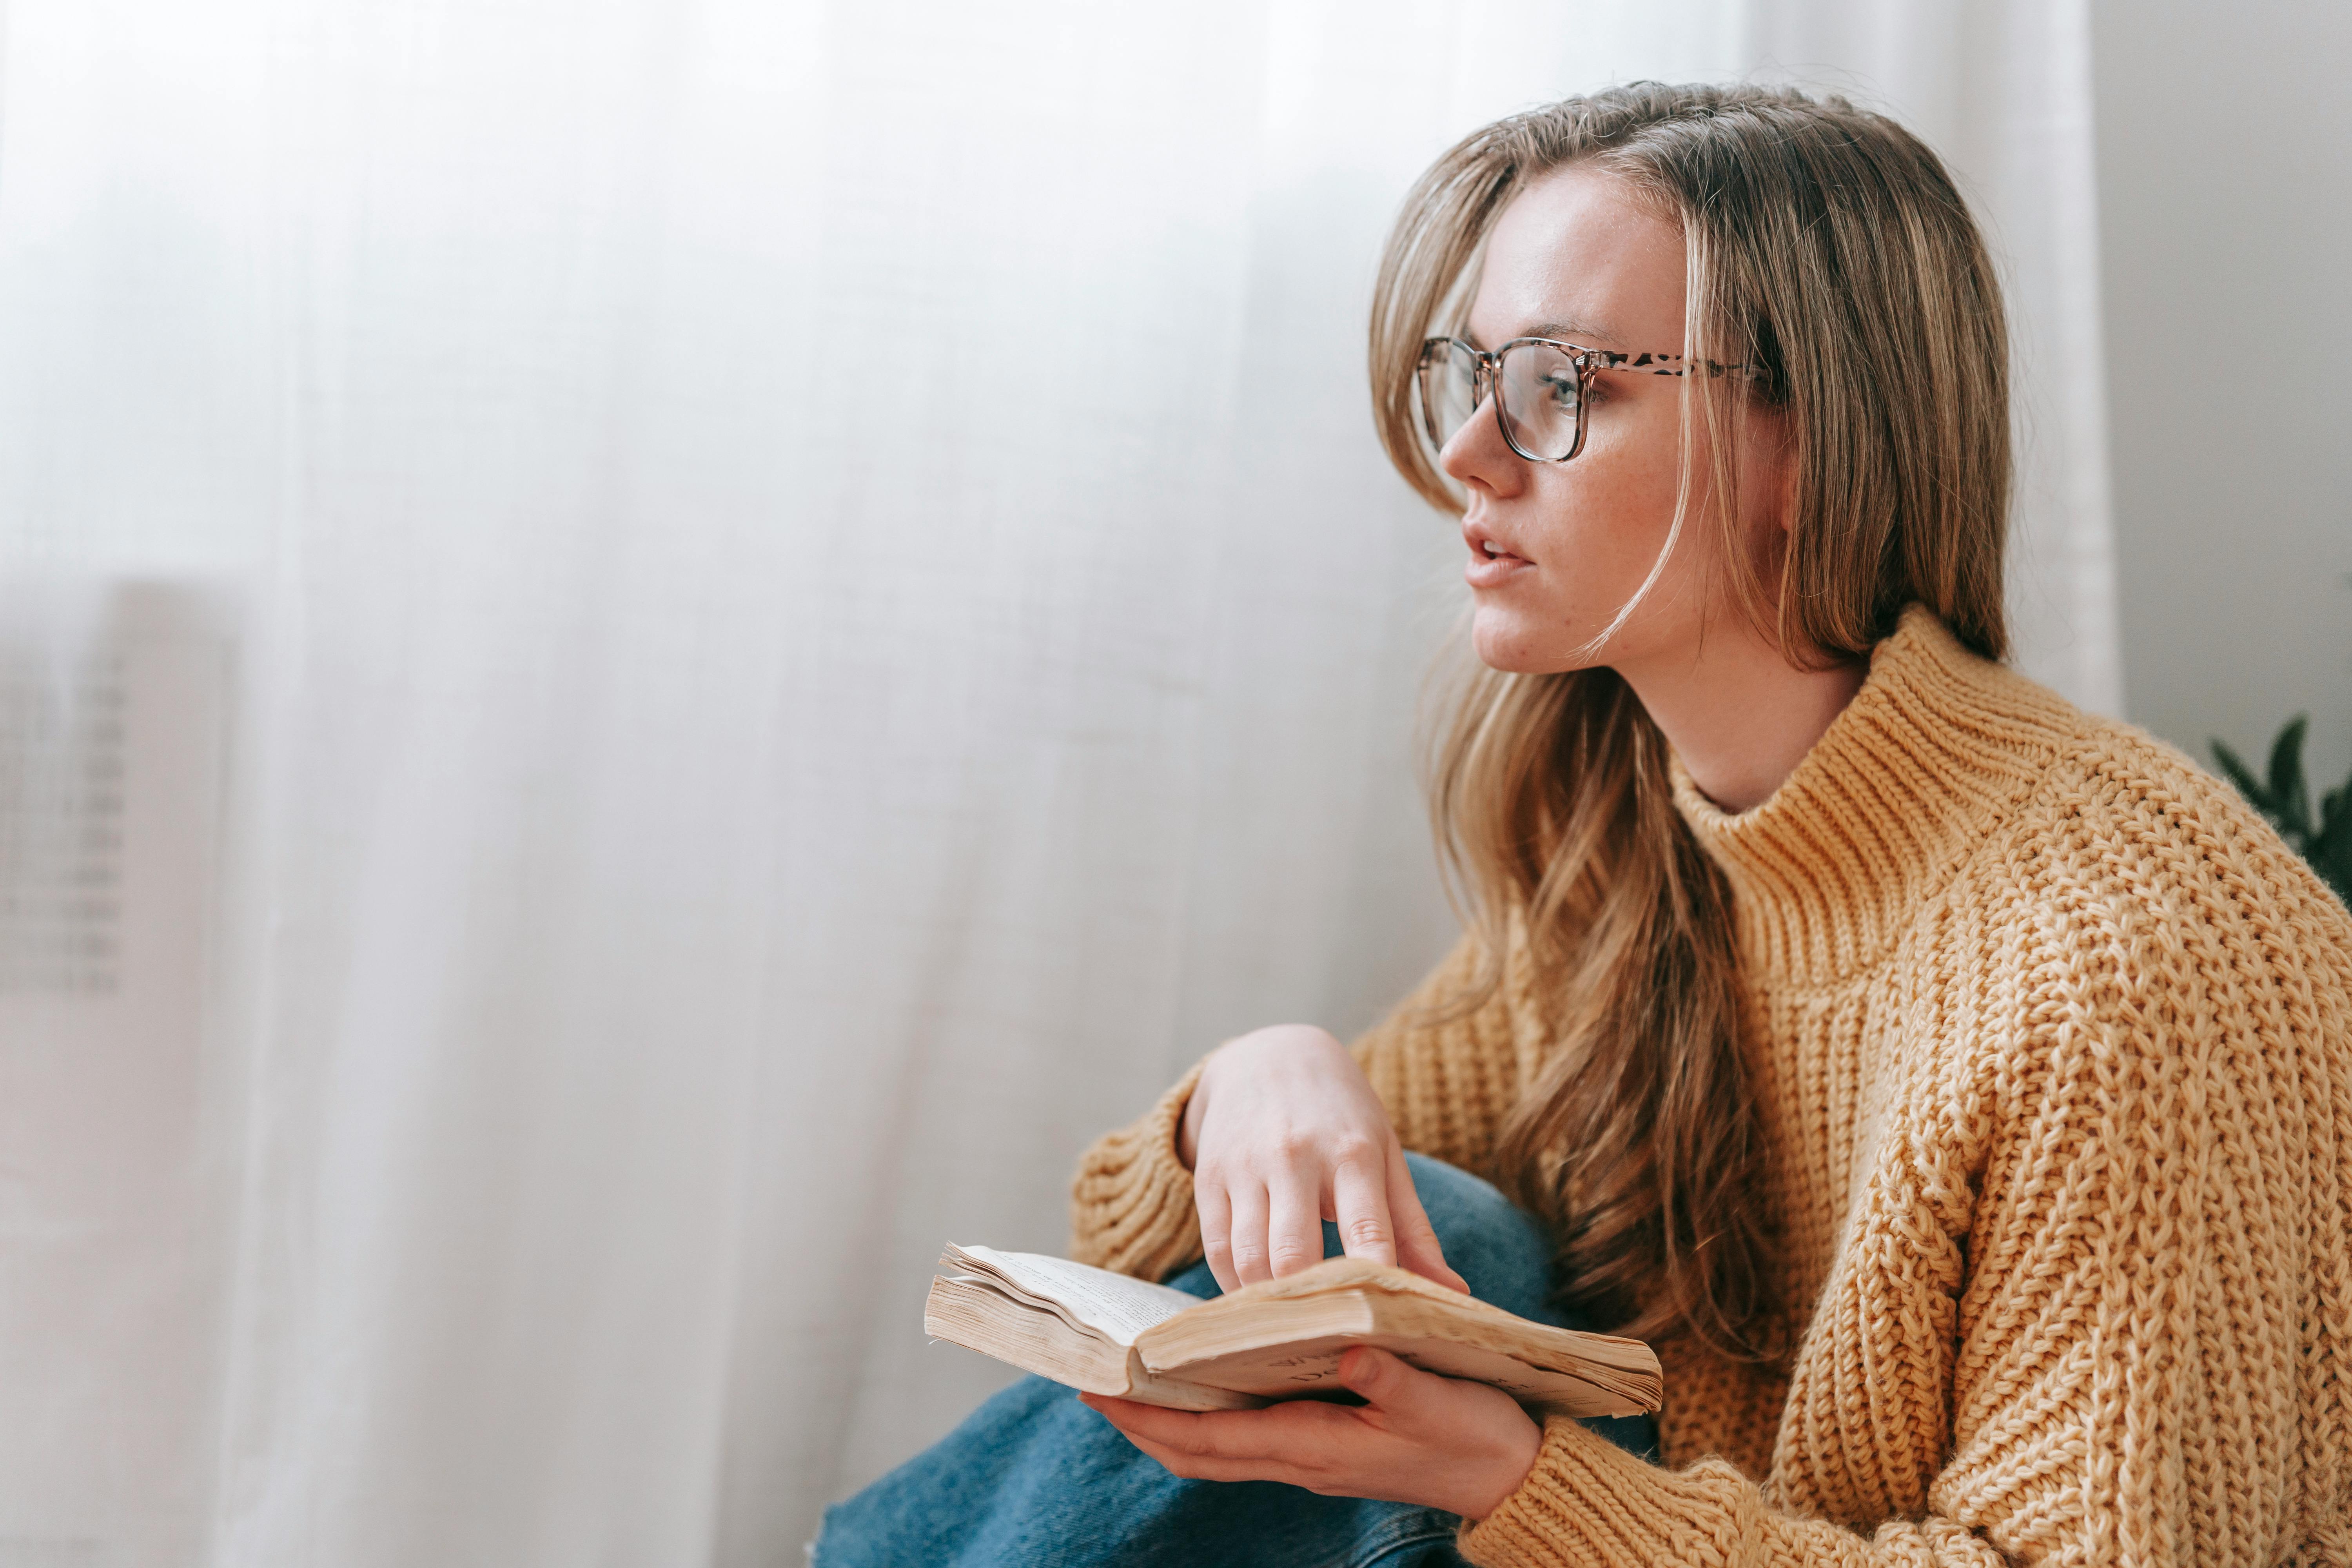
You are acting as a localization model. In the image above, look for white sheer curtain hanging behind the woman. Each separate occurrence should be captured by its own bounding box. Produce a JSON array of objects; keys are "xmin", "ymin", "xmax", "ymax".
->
[{"xmin": 0, "ymin": 0, "xmax": 2119, "ymax": 1568}]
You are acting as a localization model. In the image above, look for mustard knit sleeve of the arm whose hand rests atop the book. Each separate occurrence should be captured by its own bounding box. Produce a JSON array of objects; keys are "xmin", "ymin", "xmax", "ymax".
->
[{"xmin": 1070, "ymin": 938, "xmax": 1526, "ymax": 1279}]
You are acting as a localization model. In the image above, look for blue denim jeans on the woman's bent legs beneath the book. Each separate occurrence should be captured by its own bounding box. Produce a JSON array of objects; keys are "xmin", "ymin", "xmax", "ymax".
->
[{"xmin": 811, "ymin": 1154, "xmax": 1656, "ymax": 1568}]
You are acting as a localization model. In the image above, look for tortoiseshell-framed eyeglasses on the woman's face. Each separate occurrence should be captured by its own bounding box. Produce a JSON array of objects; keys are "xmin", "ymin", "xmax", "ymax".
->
[{"xmin": 1416, "ymin": 339, "xmax": 1764, "ymax": 463}]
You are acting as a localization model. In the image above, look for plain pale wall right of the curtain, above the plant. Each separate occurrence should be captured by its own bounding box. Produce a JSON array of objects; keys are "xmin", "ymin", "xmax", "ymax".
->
[{"xmin": 2093, "ymin": 0, "xmax": 2352, "ymax": 788}]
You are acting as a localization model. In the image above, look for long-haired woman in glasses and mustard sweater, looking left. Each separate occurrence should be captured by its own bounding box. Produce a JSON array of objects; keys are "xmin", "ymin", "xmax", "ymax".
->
[{"xmin": 818, "ymin": 85, "xmax": 2352, "ymax": 1568}]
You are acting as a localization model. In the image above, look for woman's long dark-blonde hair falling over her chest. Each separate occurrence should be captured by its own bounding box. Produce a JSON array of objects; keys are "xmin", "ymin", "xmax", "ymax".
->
[{"xmin": 1371, "ymin": 82, "xmax": 2011, "ymax": 1359}]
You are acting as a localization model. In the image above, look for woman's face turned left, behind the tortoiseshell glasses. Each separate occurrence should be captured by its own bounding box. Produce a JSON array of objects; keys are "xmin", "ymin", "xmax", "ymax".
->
[{"xmin": 1437, "ymin": 165, "xmax": 1785, "ymax": 672}]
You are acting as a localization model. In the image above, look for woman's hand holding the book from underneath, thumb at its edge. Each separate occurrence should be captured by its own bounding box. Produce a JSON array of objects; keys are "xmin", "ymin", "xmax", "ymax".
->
[{"xmin": 1080, "ymin": 1345, "xmax": 1543, "ymax": 1519}]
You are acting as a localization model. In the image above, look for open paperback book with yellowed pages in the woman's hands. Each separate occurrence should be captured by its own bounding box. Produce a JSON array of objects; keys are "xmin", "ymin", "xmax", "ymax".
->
[{"xmin": 922, "ymin": 1243, "xmax": 1665, "ymax": 1415}]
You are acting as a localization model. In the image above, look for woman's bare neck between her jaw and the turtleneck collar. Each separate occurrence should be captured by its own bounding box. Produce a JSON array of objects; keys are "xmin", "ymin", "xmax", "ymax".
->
[{"xmin": 1616, "ymin": 621, "xmax": 1870, "ymax": 813}]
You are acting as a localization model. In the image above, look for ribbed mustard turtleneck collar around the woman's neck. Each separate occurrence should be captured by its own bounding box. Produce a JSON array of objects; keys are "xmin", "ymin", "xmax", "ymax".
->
[{"xmin": 1672, "ymin": 604, "xmax": 2079, "ymax": 985}]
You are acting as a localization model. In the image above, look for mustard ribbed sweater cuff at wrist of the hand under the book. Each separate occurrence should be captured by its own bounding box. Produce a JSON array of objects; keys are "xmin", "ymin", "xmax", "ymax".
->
[{"xmin": 1458, "ymin": 1415, "xmax": 1759, "ymax": 1568}]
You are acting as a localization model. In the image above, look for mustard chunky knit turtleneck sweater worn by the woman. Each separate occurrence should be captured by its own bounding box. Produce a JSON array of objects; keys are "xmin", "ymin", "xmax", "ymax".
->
[{"xmin": 1073, "ymin": 609, "xmax": 2352, "ymax": 1568}]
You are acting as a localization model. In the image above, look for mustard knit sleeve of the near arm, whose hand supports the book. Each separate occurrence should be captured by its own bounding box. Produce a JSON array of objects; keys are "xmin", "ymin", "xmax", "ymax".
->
[{"xmin": 1461, "ymin": 867, "xmax": 2352, "ymax": 1568}]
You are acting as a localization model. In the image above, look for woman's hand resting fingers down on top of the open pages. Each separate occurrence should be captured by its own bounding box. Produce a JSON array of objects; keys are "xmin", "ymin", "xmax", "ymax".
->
[{"xmin": 1176, "ymin": 1023, "xmax": 1470, "ymax": 1293}]
